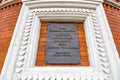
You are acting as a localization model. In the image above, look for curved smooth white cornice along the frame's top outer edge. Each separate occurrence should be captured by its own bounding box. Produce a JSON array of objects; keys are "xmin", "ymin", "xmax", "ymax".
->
[{"xmin": 23, "ymin": 0, "xmax": 101, "ymax": 9}]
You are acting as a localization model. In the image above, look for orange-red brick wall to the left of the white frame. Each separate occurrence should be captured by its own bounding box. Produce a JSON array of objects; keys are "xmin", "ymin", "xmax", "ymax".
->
[{"xmin": 0, "ymin": 0, "xmax": 22, "ymax": 72}]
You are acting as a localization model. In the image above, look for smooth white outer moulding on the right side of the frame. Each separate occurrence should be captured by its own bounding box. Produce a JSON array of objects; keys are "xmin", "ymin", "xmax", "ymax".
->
[{"xmin": 97, "ymin": 5, "xmax": 120, "ymax": 80}]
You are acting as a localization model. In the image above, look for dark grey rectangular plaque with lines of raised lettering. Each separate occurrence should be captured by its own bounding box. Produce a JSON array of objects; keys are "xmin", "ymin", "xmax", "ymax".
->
[{"xmin": 45, "ymin": 23, "xmax": 80, "ymax": 64}]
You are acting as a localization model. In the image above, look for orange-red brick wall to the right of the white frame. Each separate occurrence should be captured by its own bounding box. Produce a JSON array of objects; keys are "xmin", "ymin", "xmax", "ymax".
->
[{"xmin": 103, "ymin": 1, "xmax": 120, "ymax": 56}]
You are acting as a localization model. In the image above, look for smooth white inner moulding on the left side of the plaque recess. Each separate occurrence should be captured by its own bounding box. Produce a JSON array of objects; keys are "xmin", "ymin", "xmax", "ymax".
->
[{"xmin": 26, "ymin": 16, "xmax": 41, "ymax": 67}]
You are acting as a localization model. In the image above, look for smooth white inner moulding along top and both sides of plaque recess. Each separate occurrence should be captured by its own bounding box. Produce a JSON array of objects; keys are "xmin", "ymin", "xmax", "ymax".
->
[{"xmin": 26, "ymin": 13, "xmax": 97, "ymax": 67}]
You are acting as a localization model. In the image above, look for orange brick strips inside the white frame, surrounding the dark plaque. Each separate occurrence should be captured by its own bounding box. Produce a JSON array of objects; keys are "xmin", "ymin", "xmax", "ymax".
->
[{"xmin": 36, "ymin": 22, "xmax": 89, "ymax": 66}]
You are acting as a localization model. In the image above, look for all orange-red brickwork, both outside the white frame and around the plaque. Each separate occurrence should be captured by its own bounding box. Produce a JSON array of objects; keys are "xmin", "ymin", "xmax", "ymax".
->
[{"xmin": 0, "ymin": 0, "xmax": 120, "ymax": 72}]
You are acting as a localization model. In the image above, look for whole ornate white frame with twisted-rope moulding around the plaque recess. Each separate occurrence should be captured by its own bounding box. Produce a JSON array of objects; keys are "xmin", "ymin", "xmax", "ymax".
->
[{"xmin": 1, "ymin": 0, "xmax": 120, "ymax": 80}]
